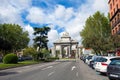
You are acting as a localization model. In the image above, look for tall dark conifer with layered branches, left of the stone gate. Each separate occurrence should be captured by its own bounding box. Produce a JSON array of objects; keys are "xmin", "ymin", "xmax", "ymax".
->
[{"xmin": 34, "ymin": 26, "xmax": 50, "ymax": 59}]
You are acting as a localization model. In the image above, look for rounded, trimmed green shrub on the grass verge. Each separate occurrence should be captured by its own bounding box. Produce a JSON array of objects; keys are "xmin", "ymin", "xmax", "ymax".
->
[{"xmin": 3, "ymin": 53, "xmax": 18, "ymax": 64}]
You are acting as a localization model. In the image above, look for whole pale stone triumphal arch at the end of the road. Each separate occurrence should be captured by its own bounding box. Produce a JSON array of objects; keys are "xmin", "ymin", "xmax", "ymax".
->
[{"xmin": 54, "ymin": 32, "xmax": 78, "ymax": 58}]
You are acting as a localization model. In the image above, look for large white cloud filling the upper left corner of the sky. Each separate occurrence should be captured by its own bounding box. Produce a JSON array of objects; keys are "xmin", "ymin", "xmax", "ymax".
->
[{"xmin": 0, "ymin": 0, "xmax": 31, "ymax": 25}]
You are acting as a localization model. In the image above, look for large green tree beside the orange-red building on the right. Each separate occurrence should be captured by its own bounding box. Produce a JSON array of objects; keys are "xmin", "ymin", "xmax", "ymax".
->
[{"xmin": 80, "ymin": 11, "xmax": 111, "ymax": 53}]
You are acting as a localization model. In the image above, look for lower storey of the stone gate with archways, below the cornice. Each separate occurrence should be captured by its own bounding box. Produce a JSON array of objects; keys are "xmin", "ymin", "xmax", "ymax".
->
[{"xmin": 55, "ymin": 44, "xmax": 78, "ymax": 58}]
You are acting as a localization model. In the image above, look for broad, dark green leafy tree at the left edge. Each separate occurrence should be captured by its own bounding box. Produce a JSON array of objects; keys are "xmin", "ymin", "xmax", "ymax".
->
[{"xmin": 0, "ymin": 24, "xmax": 29, "ymax": 52}]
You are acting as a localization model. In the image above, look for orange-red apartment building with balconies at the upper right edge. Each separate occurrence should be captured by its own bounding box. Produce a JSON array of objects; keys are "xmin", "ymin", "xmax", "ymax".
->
[{"xmin": 108, "ymin": 0, "xmax": 120, "ymax": 35}]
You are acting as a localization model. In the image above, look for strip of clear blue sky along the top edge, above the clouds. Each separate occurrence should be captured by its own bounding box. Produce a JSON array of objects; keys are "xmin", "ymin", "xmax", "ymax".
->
[{"xmin": 32, "ymin": 0, "xmax": 86, "ymax": 8}]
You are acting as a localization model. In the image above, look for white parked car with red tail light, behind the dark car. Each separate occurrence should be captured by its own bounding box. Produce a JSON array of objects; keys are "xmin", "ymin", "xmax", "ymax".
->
[{"xmin": 94, "ymin": 56, "xmax": 115, "ymax": 73}]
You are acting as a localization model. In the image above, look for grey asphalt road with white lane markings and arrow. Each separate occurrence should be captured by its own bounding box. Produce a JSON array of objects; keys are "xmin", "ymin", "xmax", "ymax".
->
[{"xmin": 0, "ymin": 60, "xmax": 108, "ymax": 80}]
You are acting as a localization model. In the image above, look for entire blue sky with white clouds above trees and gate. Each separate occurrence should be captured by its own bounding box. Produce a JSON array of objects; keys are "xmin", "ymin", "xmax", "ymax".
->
[{"xmin": 0, "ymin": 0, "xmax": 109, "ymax": 47}]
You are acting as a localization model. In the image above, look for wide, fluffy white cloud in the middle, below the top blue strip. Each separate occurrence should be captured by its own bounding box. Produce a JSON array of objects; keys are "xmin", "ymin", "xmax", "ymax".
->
[{"xmin": 26, "ymin": 5, "xmax": 74, "ymax": 27}]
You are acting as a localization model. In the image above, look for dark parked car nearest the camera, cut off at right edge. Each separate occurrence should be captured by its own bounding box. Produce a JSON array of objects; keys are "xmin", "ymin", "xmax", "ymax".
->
[{"xmin": 107, "ymin": 58, "xmax": 120, "ymax": 80}]
